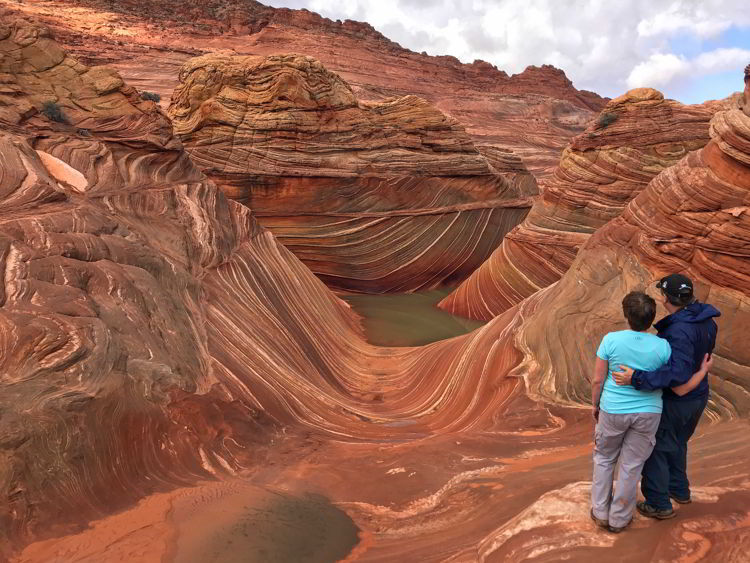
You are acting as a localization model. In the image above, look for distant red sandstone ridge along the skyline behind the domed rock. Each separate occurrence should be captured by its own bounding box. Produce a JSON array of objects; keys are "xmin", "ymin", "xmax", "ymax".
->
[{"xmin": 1, "ymin": 0, "xmax": 606, "ymax": 178}]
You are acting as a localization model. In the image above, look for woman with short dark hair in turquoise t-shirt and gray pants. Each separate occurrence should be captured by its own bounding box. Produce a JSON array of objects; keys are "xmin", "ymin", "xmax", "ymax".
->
[{"xmin": 591, "ymin": 291, "xmax": 711, "ymax": 533}]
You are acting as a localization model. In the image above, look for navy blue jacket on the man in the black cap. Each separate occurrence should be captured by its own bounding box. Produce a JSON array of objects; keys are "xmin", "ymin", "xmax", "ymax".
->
[{"xmin": 631, "ymin": 301, "xmax": 721, "ymax": 401}]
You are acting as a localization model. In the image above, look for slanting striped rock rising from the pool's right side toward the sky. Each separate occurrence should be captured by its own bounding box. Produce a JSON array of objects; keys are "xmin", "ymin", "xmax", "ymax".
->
[{"xmin": 440, "ymin": 88, "xmax": 720, "ymax": 320}]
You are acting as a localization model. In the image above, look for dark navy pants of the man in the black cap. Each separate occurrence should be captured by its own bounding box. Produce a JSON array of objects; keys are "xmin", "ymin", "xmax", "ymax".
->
[{"xmin": 641, "ymin": 398, "xmax": 708, "ymax": 510}]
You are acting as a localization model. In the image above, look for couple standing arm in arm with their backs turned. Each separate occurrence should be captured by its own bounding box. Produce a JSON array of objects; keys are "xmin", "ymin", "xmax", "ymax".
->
[{"xmin": 591, "ymin": 274, "xmax": 721, "ymax": 533}]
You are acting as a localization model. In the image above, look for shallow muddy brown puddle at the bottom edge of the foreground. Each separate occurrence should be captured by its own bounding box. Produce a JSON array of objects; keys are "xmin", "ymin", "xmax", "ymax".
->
[{"xmin": 168, "ymin": 486, "xmax": 359, "ymax": 563}]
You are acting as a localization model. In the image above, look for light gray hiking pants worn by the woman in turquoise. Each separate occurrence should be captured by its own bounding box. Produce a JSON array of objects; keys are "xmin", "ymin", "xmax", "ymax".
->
[{"xmin": 591, "ymin": 411, "xmax": 661, "ymax": 528}]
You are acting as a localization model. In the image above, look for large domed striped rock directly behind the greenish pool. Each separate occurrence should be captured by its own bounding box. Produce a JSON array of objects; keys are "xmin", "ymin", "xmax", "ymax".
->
[{"xmin": 169, "ymin": 55, "xmax": 537, "ymax": 293}]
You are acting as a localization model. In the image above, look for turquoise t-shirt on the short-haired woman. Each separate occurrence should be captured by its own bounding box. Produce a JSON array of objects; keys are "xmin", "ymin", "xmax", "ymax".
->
[{"xmin": 596, "ymin": 330, "xmax": 672, "ymax": 414}]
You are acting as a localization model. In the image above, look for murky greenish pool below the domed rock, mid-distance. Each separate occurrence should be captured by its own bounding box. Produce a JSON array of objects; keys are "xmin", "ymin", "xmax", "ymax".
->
[{"xmin": 340, "ymin": 288, "xmax": 484, "ymax": 346}]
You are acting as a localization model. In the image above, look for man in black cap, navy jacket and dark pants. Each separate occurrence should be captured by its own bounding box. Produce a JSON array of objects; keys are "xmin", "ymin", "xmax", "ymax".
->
[{"xmin": 612, "ymin": 274, "xmax": 721, "ymax": 520}]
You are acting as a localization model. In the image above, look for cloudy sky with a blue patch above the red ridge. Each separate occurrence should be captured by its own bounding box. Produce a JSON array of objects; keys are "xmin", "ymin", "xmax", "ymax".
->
[{"xmin": 264, "ymin": 0, "xmax": 750, "ymax": 103}]
